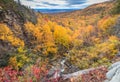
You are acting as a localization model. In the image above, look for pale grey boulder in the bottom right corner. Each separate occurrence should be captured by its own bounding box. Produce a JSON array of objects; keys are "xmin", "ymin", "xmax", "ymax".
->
[{"xmin": 105, "ymin": 62, "xmax": 120, "ymax": 82}]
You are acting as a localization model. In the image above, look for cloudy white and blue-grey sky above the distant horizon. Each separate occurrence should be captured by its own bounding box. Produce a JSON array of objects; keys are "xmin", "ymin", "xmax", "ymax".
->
[{"xmin": 15, "ymin": 0, "xmax": 108, "ymax": 9}]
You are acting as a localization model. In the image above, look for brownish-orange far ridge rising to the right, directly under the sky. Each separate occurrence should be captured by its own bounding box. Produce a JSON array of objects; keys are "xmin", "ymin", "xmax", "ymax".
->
[{"xmin": 49, "ymin": 0, "xmax": 115, "ymax": 17}]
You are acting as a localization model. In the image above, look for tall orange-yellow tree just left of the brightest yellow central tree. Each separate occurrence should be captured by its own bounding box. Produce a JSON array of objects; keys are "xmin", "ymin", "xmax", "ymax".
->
[{"xmin": 39, "ymin": 24, "xmax": 57, "ymax": 55}]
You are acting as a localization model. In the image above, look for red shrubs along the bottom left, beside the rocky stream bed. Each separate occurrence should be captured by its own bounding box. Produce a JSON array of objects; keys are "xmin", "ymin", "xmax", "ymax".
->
[{"xmin": 0, "ymin": 65, "xmax": 59, "ymax": 82}]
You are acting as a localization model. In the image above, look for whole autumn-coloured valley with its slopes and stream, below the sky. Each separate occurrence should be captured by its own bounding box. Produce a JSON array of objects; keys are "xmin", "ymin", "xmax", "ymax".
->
[{"xmin": 0, "ymin": 0, "xmax": 120, "ymax": 82}]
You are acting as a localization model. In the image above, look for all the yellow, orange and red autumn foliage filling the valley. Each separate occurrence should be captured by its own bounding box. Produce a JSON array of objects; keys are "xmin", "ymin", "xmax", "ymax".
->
[{"xmin": 0, "ymin": 0, "xmax": 120, "ymax": 82}]
